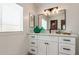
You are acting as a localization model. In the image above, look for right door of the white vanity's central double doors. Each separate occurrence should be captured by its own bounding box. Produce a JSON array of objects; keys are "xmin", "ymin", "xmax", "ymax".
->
[{"xmin": 47, "ymin": 41, "xmax": 58, "ymax": 55}]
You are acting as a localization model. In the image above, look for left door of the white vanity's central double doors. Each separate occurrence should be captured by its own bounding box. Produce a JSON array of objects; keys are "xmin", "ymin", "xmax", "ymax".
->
[{"xmin": 38, "ymin": 40, "xmax": 46, "ymax": 55}]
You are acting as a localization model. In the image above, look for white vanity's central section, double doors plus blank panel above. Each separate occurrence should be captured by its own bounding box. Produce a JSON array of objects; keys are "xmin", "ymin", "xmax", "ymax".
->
[{"xmin": 38, "ymin": 36, "xmax": 58, "ymax": 55}]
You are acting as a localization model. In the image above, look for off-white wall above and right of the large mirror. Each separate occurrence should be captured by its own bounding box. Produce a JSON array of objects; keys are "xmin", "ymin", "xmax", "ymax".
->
[{"xmin": 36, "ymin": 3, "xmax": 79, "ymax": 33}]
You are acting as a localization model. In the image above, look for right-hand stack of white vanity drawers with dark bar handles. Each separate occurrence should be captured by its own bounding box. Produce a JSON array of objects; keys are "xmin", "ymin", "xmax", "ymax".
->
[{"xmin": 59, "ymin": 37, "xmax": 76, "ymax": 55}]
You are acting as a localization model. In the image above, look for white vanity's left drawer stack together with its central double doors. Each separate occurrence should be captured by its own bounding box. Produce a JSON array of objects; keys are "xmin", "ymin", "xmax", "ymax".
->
[{"xmin": 28, "ymin": 35, "xmax": 58, "ymax": 55}]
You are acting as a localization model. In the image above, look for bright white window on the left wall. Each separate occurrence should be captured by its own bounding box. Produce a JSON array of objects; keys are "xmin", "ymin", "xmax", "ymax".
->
[{"xmin": 0, "ymin": 4, "xmax": 23, "ymax": 32}]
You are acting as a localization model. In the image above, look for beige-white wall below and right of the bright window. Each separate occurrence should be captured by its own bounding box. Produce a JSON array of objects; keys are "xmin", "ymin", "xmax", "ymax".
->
[{"xmin": 0, "ymin": 4, "xmax": 34, "ymax": 55}]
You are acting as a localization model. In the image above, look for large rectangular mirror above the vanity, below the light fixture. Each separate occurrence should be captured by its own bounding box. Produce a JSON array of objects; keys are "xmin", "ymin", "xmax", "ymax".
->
[{"xmin": 38, "ymin": 9, "xmax": 66, "ymax": 30}]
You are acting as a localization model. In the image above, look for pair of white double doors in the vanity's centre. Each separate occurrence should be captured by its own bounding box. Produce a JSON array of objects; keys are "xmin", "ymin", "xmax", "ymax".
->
[{"xmin": 38, "ymin": 40, "xmax": 58, "ymax": 55}]
